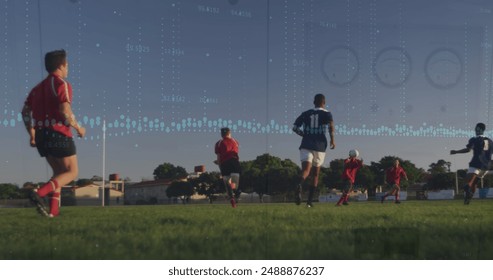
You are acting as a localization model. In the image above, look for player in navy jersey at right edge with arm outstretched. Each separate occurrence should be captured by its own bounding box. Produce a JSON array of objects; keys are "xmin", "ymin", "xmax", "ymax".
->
[{"xmin": 450, "ymin": 123, "xmax": 493, "ymax": 205}]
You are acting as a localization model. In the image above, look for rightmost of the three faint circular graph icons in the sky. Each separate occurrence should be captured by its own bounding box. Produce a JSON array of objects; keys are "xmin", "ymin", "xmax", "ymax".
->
[{"xmin": 425, "ymin": 48, "xmax": 464, "ymax": 89}]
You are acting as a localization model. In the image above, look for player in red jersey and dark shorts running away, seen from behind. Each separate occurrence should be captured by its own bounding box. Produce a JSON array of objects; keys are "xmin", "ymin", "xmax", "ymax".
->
[{"xmin": 214, "ymin": 127, "xmax": 241, "ymax": 208}]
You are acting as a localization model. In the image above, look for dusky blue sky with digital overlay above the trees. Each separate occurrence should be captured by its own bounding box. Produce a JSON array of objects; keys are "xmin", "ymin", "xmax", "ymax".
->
[{"xmin": 0, "ymin": 0, "xmax": 493, "ymax": 187}]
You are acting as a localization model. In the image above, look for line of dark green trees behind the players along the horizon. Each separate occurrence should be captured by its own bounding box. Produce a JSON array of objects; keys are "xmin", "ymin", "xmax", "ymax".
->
[{"xmin": 0, "ymin": 154, "xmax": 493, "ymax": 202}]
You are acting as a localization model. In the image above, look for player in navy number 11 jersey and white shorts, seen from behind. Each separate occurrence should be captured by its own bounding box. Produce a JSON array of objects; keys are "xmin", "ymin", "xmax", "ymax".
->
[{"xmin": 293, "ymin": 93, "xmax": 336, "ymax": 207}]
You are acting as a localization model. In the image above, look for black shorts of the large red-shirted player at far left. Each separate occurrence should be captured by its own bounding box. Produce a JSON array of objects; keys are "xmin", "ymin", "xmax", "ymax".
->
[{"xmin": 35, "ymin": 128, "xmax": 77, "ymax": 158}]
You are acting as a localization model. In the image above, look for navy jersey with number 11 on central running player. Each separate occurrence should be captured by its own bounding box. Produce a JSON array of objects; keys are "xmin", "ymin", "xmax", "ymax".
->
[{"xmin": 294, "ymin": 108, "xmax": 333, "ymax": 152}]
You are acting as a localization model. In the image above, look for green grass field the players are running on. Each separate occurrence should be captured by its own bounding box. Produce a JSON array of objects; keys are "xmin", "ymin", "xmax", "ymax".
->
[{"xmin": 0, "ymin": 200, "xmax": 493, "ymax": 260}]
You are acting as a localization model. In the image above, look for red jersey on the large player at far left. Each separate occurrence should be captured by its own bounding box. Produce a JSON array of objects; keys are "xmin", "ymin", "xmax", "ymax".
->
[{"xmin": 24, "ymin": 74, "xmax": 72, "ymax": 137}]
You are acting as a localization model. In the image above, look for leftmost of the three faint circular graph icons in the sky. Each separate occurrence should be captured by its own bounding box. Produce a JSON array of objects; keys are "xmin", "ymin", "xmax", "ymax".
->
[{"xmin": 321, "ymin": 46, "xmax": 359, "ymax": 87}]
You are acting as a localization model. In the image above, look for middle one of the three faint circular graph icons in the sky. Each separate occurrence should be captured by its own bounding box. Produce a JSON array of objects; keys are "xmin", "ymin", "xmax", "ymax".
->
[{"xmin": 373, "ymin": 47, "xmax": 412, "ymax": 88}]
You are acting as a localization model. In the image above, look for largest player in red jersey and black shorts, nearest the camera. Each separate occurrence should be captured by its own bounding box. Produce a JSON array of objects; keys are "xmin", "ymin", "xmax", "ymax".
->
[{"xmin": 22, "ymin": 50, "xmax": 86, "ymax": 217}]
